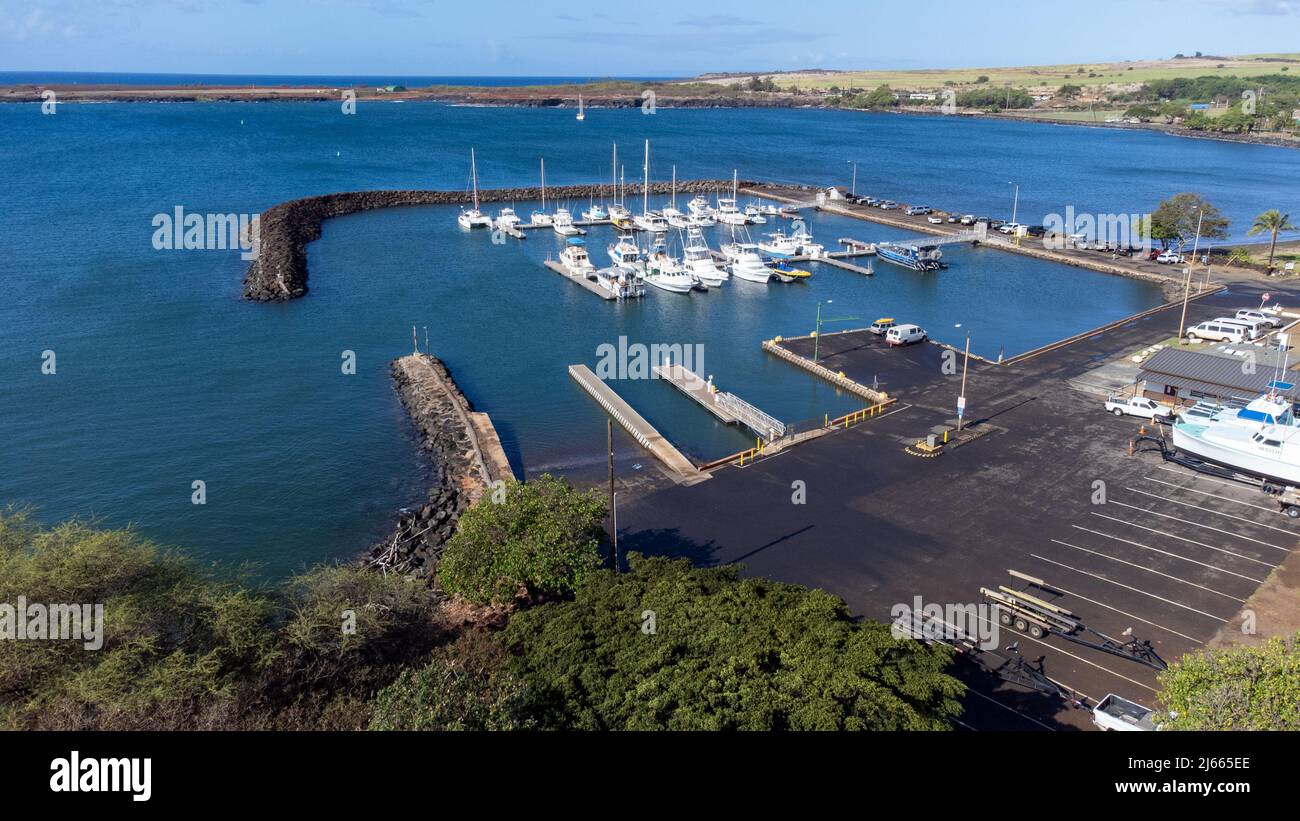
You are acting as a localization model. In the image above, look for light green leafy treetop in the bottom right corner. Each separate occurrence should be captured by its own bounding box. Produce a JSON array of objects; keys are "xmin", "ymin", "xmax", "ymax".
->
[{"xmin": 1160, "ymin": 634, "xmax": 1300, "ymax": 730}]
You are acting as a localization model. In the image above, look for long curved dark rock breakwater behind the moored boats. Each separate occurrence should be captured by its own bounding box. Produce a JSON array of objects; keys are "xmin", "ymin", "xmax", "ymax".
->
[{"xmin": 243, "ymin": 179, "xmax": 754, "ymax": 301}]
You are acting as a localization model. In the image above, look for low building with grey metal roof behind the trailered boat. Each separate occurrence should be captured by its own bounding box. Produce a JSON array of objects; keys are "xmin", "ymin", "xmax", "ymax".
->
[{"xmin": 1138, "ymin": 347, "xmax": 1300, "ymax": 401}]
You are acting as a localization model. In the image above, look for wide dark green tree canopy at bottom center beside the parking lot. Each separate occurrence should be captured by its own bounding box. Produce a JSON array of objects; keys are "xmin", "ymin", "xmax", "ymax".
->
[{"xmin": 503, "ymin": 553, "xmax": 962, "ymax": 730}]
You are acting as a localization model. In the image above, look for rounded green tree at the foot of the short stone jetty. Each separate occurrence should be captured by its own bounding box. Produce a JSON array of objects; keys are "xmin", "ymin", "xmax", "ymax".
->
[{"xmin": 438, "ymin": 474, "xmax": 606, "ymax": 604}]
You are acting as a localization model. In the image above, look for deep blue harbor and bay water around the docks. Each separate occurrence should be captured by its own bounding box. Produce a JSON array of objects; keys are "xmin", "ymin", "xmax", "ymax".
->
[{"xmin": 0, "ymin": 104, "xmax": 1300, "ymax": 574}]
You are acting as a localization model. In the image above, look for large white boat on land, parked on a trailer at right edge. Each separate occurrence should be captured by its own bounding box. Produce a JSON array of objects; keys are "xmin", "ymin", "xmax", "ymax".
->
[{"xmin": 1174, "ymin": 381, "xmax": 1300, "ymax": 485}]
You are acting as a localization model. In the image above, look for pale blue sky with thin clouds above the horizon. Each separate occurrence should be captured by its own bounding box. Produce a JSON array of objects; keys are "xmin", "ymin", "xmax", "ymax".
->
[{"xmin": 0, "ymin": 0, "xmax": 1300, "ymax": 77}]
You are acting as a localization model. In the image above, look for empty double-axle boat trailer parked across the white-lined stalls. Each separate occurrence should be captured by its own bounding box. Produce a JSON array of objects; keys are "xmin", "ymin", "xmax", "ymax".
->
[{"xmin": 979, "ymin": 570, "xmax": 1169, "ymax": 670}]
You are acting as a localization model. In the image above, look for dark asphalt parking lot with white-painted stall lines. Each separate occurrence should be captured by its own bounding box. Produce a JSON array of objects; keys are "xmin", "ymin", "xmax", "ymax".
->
[{"xmin": 619, "ymin": 279, "xmax": 1300, "ymax": 730}]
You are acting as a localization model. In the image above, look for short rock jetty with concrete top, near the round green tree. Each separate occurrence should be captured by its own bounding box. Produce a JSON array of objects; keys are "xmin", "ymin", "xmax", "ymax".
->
[{"xmin": 367, "ymin": 353, "xmax": 514, "ymax": 578}]
